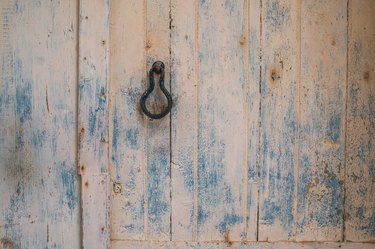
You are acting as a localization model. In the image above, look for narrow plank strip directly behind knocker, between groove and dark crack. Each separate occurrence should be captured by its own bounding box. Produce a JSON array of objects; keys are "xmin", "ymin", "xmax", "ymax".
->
[{"xmin": 144, "ymin": 0, "xmax": 173, "ymax": 241}]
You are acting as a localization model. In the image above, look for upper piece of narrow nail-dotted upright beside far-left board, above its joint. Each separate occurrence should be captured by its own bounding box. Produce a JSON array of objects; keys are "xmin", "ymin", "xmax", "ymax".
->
[{"xmin": 78, "ymin": 0, "xmax": 109, "ymax": 175}]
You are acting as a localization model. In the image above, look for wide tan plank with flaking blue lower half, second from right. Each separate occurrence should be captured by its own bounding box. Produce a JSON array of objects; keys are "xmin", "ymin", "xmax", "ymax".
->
[{"xmin": 296, "ymin": 0, "xmax": 347, "ymax": 241}]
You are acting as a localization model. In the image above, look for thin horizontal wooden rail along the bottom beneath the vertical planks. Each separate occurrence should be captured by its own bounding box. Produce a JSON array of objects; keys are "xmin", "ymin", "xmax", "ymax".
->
[{"xmin": 112, "ymin": 241, "xmax": 374, "ymax": 249}]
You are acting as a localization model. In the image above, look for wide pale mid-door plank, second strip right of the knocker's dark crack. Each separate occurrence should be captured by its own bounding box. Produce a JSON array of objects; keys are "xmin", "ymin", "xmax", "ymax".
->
[{"xmin": 197, "ymin": 0, "xmax": 248, "ymax": 241}]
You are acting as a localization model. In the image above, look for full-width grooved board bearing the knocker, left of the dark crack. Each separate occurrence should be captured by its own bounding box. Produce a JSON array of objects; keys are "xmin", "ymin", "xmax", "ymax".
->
[{"xmin": 110, "ymin": 0, "xmax": 171, "ymax": 241}]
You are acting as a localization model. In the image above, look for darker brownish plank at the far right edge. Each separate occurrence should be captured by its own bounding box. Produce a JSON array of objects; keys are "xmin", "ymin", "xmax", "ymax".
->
[{"xmin": 345, "ymin": 0, "xmax": 375, "ymax": 241}]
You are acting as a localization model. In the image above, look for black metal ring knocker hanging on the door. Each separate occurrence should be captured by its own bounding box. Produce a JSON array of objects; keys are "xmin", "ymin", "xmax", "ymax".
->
[{"xmin": 141, "ymin": 61, "xmax": 172, "ymax": 119}]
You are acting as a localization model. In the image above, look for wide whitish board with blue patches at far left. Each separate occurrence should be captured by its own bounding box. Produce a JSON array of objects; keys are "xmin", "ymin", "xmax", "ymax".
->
[{"xmin": 0, "ymin": 0, "xmax": 81, "ymax": 248}]
